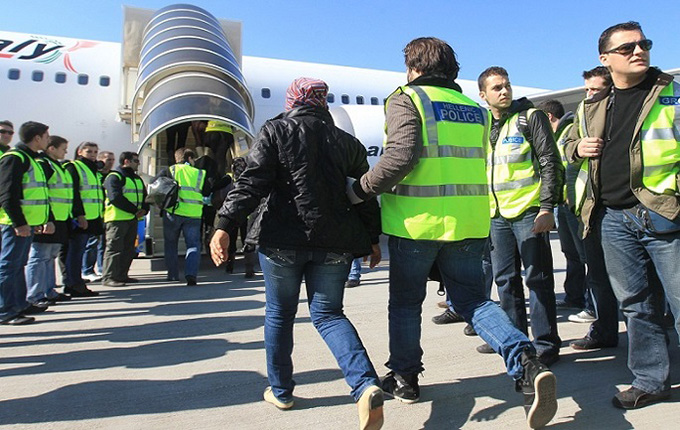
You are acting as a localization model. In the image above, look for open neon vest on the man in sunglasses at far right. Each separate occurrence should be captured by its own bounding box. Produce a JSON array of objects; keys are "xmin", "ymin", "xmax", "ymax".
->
[{"xmin": 640, "ymin": 81, "xmax": 680, "ymax": 195}]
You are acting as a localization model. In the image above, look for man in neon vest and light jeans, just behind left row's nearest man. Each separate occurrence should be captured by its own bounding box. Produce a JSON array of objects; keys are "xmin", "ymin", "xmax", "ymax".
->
[{"xmin": 25, "ymin": 136, "xmax": 73, "ymax": 306}]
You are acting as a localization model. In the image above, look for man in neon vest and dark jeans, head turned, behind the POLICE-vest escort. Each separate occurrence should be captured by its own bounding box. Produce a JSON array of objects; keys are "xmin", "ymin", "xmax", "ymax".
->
[{"xmin": 477, "ymin": 67, "xmax": 564, "ymax": 366}]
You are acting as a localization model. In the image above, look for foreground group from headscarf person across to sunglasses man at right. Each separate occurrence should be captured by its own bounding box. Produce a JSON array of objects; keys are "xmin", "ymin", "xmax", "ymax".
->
[{"xmin": 210, "ymin": 22, "xmax": 680, "ymax": 429}]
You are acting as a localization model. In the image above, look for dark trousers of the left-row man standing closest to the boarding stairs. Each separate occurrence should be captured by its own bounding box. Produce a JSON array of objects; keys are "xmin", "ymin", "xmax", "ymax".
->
[{"xmin": 102, "ymin": 219, "xmax": 137, "ymax": 282}]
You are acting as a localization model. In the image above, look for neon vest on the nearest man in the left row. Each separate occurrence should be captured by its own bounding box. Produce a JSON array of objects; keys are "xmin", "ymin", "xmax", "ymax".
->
[{"xmin": 0, "ymin": 148, "xmax": 50, "ymax": 227}]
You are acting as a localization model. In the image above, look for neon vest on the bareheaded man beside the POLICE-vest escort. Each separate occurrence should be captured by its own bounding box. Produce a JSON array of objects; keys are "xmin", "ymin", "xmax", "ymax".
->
[{"xmin": 487, "ymin": 108, "xmax": 541, "ymax": 218}]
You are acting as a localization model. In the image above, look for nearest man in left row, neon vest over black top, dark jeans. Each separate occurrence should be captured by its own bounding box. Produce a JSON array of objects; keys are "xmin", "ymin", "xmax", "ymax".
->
[{"xmin": 0, "ymin": 121, "xmax": 54, "ymax": 325}]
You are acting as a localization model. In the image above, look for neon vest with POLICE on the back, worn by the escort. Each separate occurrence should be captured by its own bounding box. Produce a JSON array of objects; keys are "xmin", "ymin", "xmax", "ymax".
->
[{"xmin": 381, "ymin": 85, "xmax": 490, "ymax": 241}]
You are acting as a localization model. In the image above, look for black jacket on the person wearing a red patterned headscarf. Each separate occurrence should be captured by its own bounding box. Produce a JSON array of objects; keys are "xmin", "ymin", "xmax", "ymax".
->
[{"xmin": 217, "ymin": 106, "xmax": 381, "ymax": 256}]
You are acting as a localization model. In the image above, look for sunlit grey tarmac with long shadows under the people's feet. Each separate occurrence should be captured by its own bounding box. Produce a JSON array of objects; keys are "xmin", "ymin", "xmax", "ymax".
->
[{"xmin": 0, "ymin": 235, "xmax": 680, "ymax": 430}]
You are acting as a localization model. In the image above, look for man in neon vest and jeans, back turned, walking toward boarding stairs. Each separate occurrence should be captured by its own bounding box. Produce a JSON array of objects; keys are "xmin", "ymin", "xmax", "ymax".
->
[{"xmin": 159, "ymin": 148, "xmax": 210, "ymax": 286}]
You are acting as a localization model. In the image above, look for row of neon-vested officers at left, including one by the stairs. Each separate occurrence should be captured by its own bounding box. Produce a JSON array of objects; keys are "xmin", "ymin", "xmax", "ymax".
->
[{"xmin": 0, "ymin": 120, "xmax": 220, "ymax": 325}]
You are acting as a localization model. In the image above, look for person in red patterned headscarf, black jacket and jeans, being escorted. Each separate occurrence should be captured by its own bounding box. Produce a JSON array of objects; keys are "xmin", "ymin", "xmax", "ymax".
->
[{"xmin": 210, "ymin": 78, "xmax": 383, "ymax": 429}]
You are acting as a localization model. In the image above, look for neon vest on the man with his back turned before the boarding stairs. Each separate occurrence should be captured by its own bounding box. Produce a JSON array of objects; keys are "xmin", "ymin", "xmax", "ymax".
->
[{"xmin": 168, "ymin": 164, "xmax": 205, "ymax": 218}]
